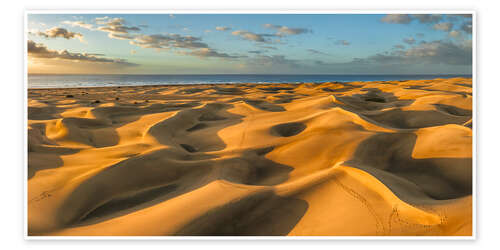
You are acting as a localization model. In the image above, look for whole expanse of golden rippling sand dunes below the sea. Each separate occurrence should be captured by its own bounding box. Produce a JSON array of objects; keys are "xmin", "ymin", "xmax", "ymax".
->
[{"xmin": 27, "ymin": 78, "xmax": 473, "ymax": 236}]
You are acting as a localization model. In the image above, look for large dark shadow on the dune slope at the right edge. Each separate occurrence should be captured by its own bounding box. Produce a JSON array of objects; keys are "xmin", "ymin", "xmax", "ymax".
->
[{"xmin": 345, "ymin": 133, "xmax": 472, "ymax": 202}]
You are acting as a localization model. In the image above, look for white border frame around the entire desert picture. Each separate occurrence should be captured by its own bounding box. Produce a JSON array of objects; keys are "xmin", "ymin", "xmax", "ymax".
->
[{"xmin": 23, "ymin": 9, "xmax": 477, "ymax": 241}]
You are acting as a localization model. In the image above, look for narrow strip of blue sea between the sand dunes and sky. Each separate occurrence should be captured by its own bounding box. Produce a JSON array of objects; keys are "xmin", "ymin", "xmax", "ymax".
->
[{"xmin": 28, "ymin": 74, "xmax": 472, "ymax": 88}]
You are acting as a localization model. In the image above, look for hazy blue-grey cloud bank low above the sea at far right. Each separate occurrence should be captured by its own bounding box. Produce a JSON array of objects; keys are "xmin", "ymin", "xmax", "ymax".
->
[{"xmin": 353, "ymin": 40, "xmax": 472, "ymax": 65}]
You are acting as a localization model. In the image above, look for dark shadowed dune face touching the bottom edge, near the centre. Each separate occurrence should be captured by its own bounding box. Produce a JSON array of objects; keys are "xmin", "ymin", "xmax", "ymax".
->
[{"xmin": 175, "ymin": 191, "xmax": 309, "ymax": 236}]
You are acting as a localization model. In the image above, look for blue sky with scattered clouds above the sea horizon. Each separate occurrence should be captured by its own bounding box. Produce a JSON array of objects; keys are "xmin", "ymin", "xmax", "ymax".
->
[{"xmin": 26, "ymin": 14, "xmax": 473, "ymax": 74}]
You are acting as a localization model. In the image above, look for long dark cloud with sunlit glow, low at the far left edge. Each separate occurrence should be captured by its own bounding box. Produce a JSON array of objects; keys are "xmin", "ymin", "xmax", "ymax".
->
[{"xmin": 28, "ymin": 40, "xmax": 138, "ymax": 66}]
